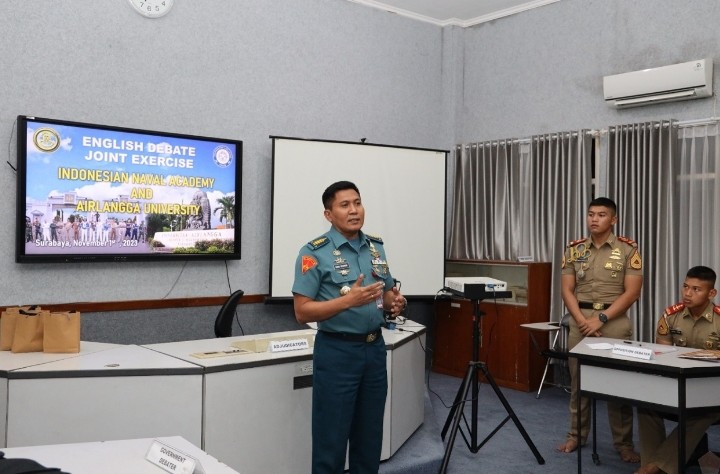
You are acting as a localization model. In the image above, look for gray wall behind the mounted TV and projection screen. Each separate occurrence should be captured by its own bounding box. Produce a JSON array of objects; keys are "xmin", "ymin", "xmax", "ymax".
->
[{"xmin": 0, "ymin": 0, "xmax": 453, "ymax": 305}]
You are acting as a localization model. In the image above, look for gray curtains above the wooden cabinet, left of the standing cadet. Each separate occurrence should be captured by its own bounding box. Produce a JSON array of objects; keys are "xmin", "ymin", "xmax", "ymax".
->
[{"xmin": 448, "ymin": 131, "xmax": 593, "ymax": 321}]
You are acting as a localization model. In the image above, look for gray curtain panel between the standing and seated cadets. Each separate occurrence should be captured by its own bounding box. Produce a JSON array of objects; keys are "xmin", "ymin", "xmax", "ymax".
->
[{"xmin": 607, "ymin": 121, "xmax": 676, "ymax": 341}]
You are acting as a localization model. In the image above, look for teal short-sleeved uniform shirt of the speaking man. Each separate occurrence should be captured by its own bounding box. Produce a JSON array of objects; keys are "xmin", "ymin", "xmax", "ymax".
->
[{"xmin": 292, "ymin": 227, "xmax": 395, "ymax": 334}]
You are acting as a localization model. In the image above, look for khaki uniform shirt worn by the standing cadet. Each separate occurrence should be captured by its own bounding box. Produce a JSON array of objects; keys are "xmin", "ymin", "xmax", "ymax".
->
[{"xmin": 562, "ymin": 233, "xmax": 642, "ymax": 304}]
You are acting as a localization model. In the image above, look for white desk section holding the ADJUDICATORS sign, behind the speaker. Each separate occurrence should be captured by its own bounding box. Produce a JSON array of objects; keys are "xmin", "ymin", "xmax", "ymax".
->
[{"xmin": 146, "ymin": 321, "xmax": 425, "ymax": 474}]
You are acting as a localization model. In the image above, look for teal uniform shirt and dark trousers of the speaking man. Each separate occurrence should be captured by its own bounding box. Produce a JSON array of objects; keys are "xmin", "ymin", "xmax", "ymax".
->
[{"xmin": 292, "ymin": 227, "xmax": 394, "ymax": 474}]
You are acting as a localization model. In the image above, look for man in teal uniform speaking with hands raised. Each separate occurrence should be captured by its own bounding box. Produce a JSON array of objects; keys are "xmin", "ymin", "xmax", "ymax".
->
[{"xmin": 292, "ymin": 181, "xmax": 407, "ymax": 474}]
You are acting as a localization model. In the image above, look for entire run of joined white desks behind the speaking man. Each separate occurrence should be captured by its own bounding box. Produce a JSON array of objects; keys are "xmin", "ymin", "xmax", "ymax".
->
[{"xmin": 0, "ymin": 321, "xmax": 425, "ymax": 474}]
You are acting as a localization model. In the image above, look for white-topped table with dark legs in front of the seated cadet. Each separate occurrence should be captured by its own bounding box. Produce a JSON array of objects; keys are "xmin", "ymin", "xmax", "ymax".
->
[{"xmin": 568, "ymin": 337, "xmax": 720, "ymax": 472}]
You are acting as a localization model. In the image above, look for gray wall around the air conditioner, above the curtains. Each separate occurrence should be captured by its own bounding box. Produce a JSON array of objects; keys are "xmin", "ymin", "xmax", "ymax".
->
[{"xmin": 456, "ymin": 0, "xmax": 720, "ymax": 143}]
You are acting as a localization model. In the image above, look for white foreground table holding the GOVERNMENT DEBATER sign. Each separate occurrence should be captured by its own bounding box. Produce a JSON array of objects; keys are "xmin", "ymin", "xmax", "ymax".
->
[{"xmin": 2, "ymin": 436, "xmax": 238, "ymax": 474}]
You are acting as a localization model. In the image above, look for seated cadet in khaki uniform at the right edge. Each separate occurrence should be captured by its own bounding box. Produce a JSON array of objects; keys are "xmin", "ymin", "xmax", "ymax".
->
[{"xmin": 636, "ymin": 266, "xmax": 720, "ymax": 474}]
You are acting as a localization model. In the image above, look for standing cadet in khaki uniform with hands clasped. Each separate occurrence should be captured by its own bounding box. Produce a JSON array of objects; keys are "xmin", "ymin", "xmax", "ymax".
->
[{"xmin": 557, "ymin": 198, "xmax": 642, "ymax": 462}]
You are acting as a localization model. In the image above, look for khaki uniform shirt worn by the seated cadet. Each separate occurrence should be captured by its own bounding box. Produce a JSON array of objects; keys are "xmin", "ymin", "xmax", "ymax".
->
[{"xmin": 655, "ymin": 303, "xmax": 720, "ymax": 349}]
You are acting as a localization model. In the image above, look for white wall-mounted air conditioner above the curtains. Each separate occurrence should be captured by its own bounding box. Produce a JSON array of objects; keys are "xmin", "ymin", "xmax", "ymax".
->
[{"xmin": 603, "ymin": 58, "xmax": 713, "ymax": 109}]
